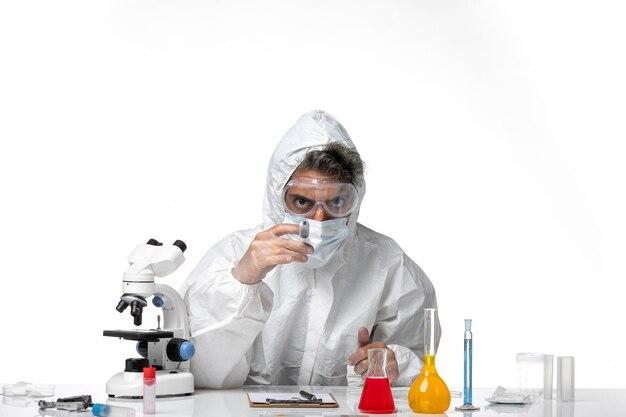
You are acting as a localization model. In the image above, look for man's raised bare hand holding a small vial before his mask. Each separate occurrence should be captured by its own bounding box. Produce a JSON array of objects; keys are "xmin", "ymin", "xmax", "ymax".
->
[{"xmin": 232, "ymin": 223, "xmax": 313, "ymax": 284}]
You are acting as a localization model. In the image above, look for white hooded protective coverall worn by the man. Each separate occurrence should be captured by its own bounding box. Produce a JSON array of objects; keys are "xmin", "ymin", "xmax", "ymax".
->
[{"xmin": 181, "ymin": 111, "xmax": 439, "ymax": 388}]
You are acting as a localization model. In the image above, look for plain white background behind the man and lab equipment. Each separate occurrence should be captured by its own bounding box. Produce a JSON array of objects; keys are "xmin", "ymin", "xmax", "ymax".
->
[{"xmin": 0, "ymin": 0, "xmax": 626, "ymax": 389}]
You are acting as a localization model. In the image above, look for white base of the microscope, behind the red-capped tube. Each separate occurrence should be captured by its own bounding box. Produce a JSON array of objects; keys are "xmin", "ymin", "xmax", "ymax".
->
[{"xmin": 107, "ymin": 370, "xmax": 194, "ymax": 398}]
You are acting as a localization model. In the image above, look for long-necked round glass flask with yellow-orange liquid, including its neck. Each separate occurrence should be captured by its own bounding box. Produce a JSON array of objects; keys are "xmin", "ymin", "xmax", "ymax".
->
[{"xmin": 409, "ymin": 308, "xmax": 450, "ymax": 414}]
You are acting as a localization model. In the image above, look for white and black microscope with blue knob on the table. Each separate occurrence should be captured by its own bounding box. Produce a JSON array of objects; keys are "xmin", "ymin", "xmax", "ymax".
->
[{"xmin": 103, "ymin": 239, "xmax": 195, "ymax": 398}]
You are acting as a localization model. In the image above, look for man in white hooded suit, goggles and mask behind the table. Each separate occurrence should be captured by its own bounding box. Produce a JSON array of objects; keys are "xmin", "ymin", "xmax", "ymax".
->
[{"xmin": 181, "ymin": 111, "xmax": 439, "ymax": 388}]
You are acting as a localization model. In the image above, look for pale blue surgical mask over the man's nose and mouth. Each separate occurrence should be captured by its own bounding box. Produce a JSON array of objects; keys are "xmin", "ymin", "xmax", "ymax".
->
[{"xmin": 284, "ymin": 213, "xmax": 350, "ymax": 268}]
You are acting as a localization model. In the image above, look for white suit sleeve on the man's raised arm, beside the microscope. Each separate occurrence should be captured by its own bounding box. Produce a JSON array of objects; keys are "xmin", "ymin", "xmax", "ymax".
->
[{"xmin": 181, "ymin": 234, "xmax": 273, "ymax": 389}]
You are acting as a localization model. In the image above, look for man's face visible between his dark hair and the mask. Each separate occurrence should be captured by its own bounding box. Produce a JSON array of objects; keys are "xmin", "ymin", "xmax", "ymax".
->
[{"xmin": 283, "ymin": 170, "xmax": 358, "ymax": 222}]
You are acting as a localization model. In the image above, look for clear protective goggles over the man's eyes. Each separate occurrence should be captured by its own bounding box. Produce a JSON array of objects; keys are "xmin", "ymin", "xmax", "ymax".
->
[{"xmin": 282, "ymin": 178, "xmax": 359, "ymax": 217}]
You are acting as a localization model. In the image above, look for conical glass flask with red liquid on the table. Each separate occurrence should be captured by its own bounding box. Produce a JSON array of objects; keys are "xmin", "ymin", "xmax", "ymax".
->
[{"xmin": 359, "ymin": 349, "xmax": 396, "ymax": 414}]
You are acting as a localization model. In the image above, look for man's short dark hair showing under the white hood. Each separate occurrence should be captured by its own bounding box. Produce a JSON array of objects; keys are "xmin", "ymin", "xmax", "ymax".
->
[{"xmin": 296, "ymin": 142, "xmax": 365, "ymax": 186}]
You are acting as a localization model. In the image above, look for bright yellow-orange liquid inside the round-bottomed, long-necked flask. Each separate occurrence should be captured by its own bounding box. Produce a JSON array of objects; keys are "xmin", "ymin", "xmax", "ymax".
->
[{"xmin": 409, "ymin": 355, "xmax": 450, "ymax": 414}]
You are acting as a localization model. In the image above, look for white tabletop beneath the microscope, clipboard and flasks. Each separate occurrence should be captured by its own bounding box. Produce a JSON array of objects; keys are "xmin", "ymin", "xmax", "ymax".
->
[{"xmin": 0, "ymin": 384, "xmax": 626, "ymax": 417}]
